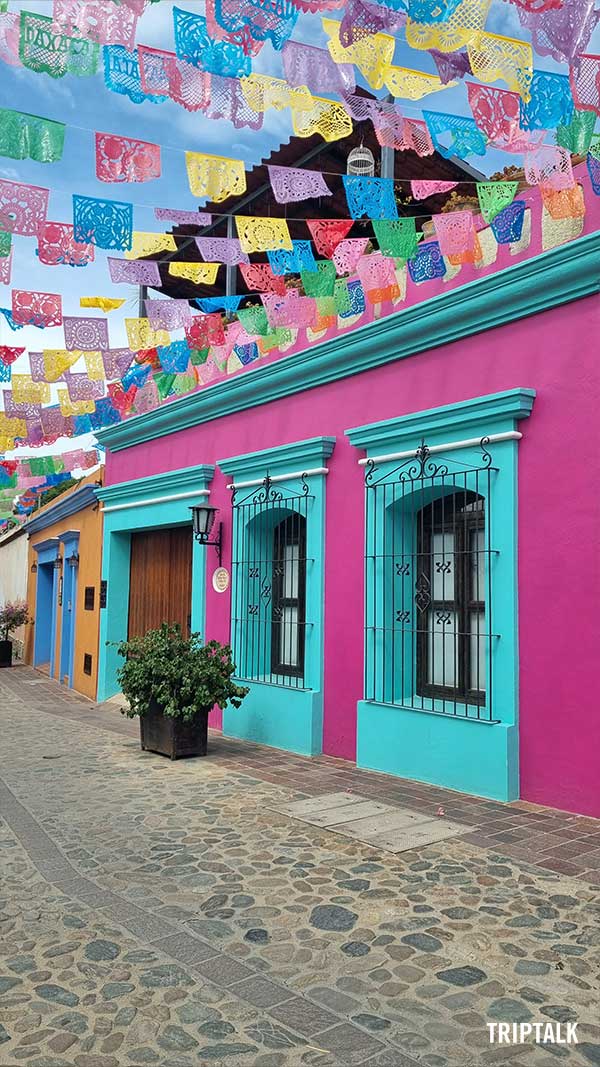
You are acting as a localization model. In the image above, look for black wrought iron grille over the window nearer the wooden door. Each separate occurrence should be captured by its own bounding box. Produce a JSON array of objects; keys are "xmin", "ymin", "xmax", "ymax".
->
[{"xmin": 232, "ymin": 474, "xmax": 314, "ymax": 688}]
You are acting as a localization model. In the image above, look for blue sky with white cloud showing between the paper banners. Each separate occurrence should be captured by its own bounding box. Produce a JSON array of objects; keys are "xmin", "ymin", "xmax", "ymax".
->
[{"xmin": 0, "ymin": 0, "xmax": 600, "ymax": 457}]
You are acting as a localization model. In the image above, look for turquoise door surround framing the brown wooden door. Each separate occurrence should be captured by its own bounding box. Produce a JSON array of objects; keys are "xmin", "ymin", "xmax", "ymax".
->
[{"xmin": 97, "ymin": 464, "xmax": 215, "ymax": 701}]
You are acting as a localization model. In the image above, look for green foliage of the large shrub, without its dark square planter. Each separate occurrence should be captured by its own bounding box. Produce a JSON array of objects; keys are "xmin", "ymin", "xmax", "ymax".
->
[{"xmin": 116, "ymin": 622, "xmax": 249, "ymax": 721}]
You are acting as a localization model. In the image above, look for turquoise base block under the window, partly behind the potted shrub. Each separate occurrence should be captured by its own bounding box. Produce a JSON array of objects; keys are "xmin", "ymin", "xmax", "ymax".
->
[{"xmin": 223, "ymin": 679, "xmax": 322, "ymax": 755}]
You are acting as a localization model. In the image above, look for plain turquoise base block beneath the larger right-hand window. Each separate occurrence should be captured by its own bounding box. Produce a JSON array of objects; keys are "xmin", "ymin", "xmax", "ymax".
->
[{"xmin": 357, "ymin": 700, "xmax": 519, "ymax": 800}]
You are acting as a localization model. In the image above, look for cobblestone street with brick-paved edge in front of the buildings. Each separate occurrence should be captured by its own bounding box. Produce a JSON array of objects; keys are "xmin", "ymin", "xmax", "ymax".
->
[{"xmin": 0, "ymin": 668, "xmax": 600, "ymax": 1067}]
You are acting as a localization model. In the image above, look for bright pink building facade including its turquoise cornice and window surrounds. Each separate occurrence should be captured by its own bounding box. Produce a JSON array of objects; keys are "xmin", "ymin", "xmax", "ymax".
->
[{"xmin": 98, "ymin": 179, "xmax": 600, "ymax": 816}]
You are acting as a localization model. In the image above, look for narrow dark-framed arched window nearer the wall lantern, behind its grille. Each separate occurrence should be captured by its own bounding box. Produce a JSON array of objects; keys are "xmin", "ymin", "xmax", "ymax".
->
[{"xmin": 271, "ymin": 511, "xmax": 306, "ymax": 679}]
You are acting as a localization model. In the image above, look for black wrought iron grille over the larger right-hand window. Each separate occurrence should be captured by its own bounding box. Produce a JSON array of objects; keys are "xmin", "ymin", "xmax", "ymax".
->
[{"xmin": 365, "ymin": 437, "xmax": 500, "ymax": 722}]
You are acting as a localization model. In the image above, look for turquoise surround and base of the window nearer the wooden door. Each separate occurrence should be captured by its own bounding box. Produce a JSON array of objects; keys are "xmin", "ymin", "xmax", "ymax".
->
[{"xmin": 219, "ymin": 437, "xmax": 335, "ymax": 755}]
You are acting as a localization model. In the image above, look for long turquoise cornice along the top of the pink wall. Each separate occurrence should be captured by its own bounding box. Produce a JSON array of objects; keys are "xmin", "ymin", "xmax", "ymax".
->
[{"xmin": 97, "ymin": 232, "xmax": 600, "ymax": 452}]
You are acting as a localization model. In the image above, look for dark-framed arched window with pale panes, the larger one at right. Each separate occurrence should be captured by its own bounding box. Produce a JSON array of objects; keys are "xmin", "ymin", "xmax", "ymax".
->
[{"xmin": 415, "ymin": 490, "xmax": 486, "ymax": 704}]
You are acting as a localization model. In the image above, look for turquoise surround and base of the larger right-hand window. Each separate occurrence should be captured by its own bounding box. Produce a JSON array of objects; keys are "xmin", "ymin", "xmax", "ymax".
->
[{"xmin": 346, "ymin": 388, "xmax": 535, "ymax": 800}]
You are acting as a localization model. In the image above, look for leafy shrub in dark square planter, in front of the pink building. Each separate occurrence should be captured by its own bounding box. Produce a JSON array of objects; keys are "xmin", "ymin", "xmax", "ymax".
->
[{"xmin": 116, "ymin": 622, "xmax": 249, "ymax": 760}]
